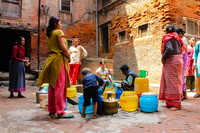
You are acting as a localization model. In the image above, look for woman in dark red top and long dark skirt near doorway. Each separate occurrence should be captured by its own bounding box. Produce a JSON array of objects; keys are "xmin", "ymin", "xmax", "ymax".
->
[{"xmin": 8, "ymin": 36, "xmax": 28, "ymax": 98}]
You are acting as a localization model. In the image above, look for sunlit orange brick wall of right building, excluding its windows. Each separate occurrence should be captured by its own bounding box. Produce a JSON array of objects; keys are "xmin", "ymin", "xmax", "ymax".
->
[{"xmin": 99, "ymin": 0, "xmax": 200, "ymax": 83}]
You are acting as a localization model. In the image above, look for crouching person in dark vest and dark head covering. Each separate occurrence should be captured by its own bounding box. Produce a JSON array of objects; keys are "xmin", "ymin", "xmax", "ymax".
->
[{"xmin": 119, "ymin": 65, "xmax": 138, "ymax": 91}]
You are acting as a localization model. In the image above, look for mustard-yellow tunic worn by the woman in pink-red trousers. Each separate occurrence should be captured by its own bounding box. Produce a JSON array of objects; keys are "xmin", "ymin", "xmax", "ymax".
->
[{"xmin": 37, "ymin": 30, "xmax": 70, "ymax": 88}]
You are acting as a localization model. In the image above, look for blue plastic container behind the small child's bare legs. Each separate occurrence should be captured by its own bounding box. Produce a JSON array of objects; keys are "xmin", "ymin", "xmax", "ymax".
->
[{"xmin": 78, "ymin": 95, "xmax": 93, "ymax": 114}]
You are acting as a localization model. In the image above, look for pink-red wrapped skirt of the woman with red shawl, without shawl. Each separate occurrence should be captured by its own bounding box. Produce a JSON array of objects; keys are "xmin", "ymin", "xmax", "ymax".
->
[{"xmin": 159, "ymin": 55, "xmax": 183, "ymax": 100}]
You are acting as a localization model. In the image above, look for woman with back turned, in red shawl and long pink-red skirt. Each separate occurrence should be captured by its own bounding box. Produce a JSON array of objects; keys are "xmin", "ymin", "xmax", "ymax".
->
[{"xmin": 159, "ymin": 25, "xmax": 184, "ymax": 110}]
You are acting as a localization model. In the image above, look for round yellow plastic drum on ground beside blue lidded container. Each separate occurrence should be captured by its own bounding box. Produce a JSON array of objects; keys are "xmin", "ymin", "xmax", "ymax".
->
[{"xmin": 120, "ymin": 91, "xmax": 138, "ymax": 112}]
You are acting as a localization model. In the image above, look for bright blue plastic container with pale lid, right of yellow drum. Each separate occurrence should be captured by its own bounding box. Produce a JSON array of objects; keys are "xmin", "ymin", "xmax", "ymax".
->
[{"xmin": 140, "ymin": 92, "xmax": 158, "ymax": 112}]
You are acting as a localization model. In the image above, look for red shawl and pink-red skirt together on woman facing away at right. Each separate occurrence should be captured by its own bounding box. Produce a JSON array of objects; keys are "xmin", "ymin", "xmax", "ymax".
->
[{"xmin": 159, "ymin": 33, "xmax": 185, "ymax": 108}]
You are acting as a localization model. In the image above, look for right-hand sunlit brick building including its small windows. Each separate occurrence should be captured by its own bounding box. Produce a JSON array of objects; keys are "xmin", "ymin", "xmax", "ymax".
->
[{"xmin": 98, "ymin": 0, "xmax": 200, "ymax": 83}]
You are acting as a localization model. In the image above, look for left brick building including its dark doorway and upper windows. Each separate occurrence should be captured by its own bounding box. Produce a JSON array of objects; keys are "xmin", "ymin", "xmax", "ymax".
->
[{"xmin": 0, "ymin": 0, "xmax": 96, "ymax": 71}]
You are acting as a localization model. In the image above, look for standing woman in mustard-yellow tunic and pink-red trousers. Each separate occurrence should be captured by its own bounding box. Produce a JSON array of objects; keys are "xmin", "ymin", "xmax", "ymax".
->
[{"xmin": 37, "ymin": 17, "xmax": 74, "ymax": 118}]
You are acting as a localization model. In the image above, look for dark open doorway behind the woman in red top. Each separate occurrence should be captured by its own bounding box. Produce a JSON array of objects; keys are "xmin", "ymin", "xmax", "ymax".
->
[{"xmin": 0, "ymin": 28, "xmax": 31, "ymax": 72}]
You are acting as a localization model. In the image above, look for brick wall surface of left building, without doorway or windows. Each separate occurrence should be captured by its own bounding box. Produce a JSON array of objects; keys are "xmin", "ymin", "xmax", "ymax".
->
[{"xmin": 0, "ymin": 0, "xmax": 96, "ymax": 69}]
